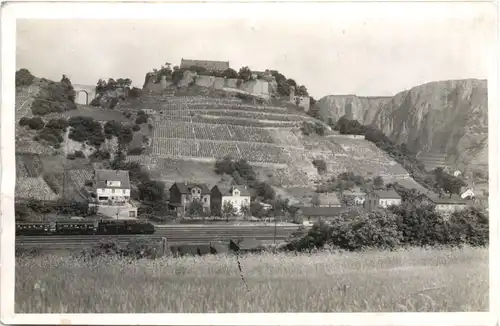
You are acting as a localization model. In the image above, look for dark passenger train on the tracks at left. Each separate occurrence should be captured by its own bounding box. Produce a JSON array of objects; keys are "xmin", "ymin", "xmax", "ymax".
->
[{"xmin": 16, "ymin": 220, "xmax": 155, "ymax": 236}]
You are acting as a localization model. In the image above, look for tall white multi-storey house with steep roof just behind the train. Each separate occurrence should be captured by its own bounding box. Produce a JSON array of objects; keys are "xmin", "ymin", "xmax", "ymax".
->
[{"xmin": 92, "ymin": 169, "xmax": 137, "ymax": 218}]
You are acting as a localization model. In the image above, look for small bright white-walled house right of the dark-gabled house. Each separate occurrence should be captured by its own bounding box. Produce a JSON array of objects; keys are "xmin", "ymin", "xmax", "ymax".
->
[{"xmin": 210, "ymin": 185, "xmax": 250, "ymax": 216}]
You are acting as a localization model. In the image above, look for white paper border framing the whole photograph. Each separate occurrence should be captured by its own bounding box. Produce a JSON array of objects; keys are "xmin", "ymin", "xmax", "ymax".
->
[{"xmin": 0, "ymin": 1, "xmax": 500, "ymax": 325}]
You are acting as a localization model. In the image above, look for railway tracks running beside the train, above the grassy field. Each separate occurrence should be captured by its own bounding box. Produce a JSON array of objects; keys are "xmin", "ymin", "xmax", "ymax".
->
[{"xmin": 16, "ymin": 225, "xmax": 298, "ymax": 249}]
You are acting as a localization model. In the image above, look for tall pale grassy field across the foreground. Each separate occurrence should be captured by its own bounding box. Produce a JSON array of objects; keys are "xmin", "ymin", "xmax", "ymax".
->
[{"xmin": 15, "ymin": 248, "xmax": 488, "ymax": 313}]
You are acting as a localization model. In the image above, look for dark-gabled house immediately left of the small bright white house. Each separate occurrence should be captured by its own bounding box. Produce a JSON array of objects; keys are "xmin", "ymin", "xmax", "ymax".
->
[{"xmin": 169, "ymin": 182, "xmax": 210, "ymax": 215}]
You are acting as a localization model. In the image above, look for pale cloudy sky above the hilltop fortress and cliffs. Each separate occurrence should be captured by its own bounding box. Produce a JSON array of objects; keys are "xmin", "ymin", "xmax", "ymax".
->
[{"xmin": 16, "ymin": 3, "xmax": 495, "ymax": 99}]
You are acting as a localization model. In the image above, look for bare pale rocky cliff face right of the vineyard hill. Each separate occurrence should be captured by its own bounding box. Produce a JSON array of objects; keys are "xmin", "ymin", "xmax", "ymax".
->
[{"xmin": 318, "ymin": 79, "xmax": 488, "ymax": 170}]
